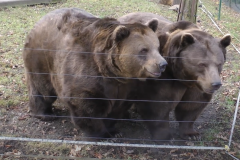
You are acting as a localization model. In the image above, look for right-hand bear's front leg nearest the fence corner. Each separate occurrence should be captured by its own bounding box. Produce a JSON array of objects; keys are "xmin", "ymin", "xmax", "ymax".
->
[{"xmin": 175, "ymin": 88, "xmax": 212, "ymax": 139}]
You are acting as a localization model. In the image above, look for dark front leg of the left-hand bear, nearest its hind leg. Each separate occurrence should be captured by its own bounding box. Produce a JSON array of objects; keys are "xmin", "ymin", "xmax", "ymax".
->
[{"xmin": 64, "ymin": 92, "xmax": 111, "ymax": 141}]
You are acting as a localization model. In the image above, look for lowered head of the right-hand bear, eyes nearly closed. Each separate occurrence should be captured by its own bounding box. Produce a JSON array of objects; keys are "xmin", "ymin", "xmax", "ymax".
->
[{"xmin": 163, "ymin": 28, "xmax": 231, "ymax": 94}]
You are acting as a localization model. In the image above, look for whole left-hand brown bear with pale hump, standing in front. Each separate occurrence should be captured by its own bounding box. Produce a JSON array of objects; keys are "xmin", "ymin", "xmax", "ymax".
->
[{"xmin": 23, "ymin": 8, "xmax": 167, "ymax": 137}]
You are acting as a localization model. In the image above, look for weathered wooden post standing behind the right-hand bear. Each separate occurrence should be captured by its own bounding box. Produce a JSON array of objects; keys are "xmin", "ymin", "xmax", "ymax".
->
[{"xmin": 177, "ymin": 0, "xmax": 198, "ymax": 23}]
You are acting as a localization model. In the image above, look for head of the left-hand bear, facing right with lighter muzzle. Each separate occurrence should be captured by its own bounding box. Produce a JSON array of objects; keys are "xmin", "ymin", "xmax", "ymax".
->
[{"xmin": 94, "ymin": 20, "xmax": 167, "ymax": 79}]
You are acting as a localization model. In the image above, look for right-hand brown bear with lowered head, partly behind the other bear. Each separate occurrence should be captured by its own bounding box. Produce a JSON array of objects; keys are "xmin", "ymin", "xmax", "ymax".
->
[{"xmin": 118, "ymin": 12, "xmax": 231, "ymax": 140}]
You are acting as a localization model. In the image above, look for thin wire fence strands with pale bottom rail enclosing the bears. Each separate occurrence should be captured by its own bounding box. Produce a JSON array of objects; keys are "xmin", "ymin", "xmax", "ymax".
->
[{"xmin": 0, "ymin": 1, "xmax": 240, "ymax": 159}]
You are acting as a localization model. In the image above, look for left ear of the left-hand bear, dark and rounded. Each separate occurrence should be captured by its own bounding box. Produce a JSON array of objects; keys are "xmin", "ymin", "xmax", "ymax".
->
[{"xmin": 113, "ymin": 25, "xmax": 130, "ymax": 42}]
